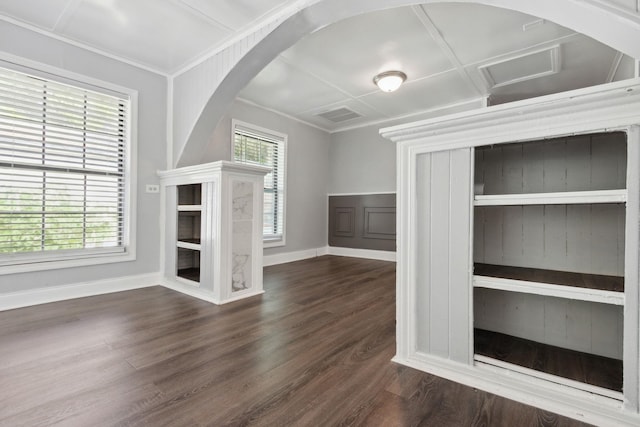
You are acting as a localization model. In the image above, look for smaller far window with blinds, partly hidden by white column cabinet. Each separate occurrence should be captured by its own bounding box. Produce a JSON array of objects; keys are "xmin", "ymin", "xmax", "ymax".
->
[{"xmin": 233, "ymin": 121, "xmax": 287, "ymax": 244}]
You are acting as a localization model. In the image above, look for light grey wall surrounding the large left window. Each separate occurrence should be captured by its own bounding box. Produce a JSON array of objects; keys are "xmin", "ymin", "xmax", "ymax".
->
[{"xmin": 0, "ymin": 21, "xmax": 167, "ymax": 294}]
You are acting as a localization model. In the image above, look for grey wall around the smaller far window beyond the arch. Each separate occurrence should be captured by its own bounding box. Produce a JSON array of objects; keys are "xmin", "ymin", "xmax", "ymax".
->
[{"xmin": 202, "ymin": 101, "xmax": 330, "ymax": 255}]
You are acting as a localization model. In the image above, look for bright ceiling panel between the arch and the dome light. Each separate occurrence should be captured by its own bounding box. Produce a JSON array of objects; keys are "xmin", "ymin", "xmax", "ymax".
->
[{"xmin": 282, "ymin": 7, "xmax": 453, "ymax": 96}]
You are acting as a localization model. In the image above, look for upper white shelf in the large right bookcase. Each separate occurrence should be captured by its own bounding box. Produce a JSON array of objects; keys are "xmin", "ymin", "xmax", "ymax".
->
[{"xmin": 474, "ymin": 190, "xmax": 627, "ymax": 206}]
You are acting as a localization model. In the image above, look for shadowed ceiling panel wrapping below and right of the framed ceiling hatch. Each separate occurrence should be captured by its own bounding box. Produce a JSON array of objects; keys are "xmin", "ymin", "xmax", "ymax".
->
[{"xmin": 491, "ymin": 36, "xmax": 616, "ymax": 104}]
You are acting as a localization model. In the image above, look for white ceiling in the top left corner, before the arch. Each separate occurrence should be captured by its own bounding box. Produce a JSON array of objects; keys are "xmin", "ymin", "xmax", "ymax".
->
[{"xmin": 0, "ymin": 0, "xmax": 294, "ymax": 74}]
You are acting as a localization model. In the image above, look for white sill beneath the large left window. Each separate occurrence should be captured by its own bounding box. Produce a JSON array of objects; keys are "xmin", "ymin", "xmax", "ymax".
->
[{"xmin": 0, "ymin": 250, "xmax": 136, "ymax": 276}]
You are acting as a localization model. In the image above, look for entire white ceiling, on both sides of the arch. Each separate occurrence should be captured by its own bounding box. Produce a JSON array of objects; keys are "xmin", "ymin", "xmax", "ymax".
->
[{"xmin": 0, "ymin": 0, "xmax": 633, "ymax": 132}]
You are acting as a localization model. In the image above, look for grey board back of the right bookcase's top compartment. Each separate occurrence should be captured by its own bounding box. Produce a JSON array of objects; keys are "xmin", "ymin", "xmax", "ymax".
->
[{"xmin": 474, "ymin": 132, "xmax": 627, "ymax": 194}]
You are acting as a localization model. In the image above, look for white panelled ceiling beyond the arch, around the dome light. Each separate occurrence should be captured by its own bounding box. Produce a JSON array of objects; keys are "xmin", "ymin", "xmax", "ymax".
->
[{"xmin": 239, "ymin": 3, "xmax": 631, "ymax": 132}]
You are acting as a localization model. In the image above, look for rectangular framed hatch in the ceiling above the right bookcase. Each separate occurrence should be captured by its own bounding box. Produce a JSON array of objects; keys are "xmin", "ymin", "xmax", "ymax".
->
[{"xmin": 478, "ymin": 45, "xmax": 560, "ymax": 88}]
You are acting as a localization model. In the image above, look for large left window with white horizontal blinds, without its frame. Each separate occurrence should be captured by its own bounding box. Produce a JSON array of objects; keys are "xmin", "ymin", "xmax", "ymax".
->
[{"xmin": 0, "ymin": 63, "xmax": 130, "ymax": 261}]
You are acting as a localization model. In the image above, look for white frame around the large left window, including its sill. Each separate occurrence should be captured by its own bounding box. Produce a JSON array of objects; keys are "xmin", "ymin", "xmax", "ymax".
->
[{"xmin": 0, "ymin": 53, "xmax": 138, "ymax": 276}]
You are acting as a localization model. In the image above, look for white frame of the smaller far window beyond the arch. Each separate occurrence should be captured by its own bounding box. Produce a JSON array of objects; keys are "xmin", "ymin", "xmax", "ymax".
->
[{"xmin": 230, "ymin": 119, "xmax": 288, "ymax": 248}]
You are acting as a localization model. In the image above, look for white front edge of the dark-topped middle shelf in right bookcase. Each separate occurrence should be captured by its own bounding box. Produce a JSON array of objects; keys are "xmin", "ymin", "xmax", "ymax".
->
[{"xmin": 473, "ymin": 275, "xmax": 624, "ymax": 305}]
